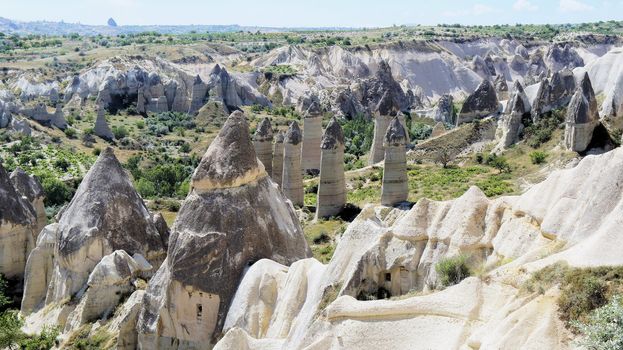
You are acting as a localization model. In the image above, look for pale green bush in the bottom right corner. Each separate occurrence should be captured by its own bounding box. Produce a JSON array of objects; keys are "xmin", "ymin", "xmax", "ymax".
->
[{"xmin": 573, "ymin": 295, "xmax": 623, "ymax": 350}]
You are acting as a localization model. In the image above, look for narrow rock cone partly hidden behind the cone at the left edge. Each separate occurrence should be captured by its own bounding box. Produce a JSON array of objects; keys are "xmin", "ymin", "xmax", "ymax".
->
[{"xmin": 10, "ymin": 168, "xmax": 48, "ymax": 239}]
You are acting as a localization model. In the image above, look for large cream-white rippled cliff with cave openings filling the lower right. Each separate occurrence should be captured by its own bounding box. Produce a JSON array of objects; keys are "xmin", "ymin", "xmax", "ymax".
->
[{"xmin": 216, "ymin": 149, "xmax": 623, "ymax": 349}]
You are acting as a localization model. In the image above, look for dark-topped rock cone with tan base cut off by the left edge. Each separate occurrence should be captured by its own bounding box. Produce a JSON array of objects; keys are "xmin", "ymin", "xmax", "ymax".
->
[{"xmin": 0, "ymin": 162, "xmax": 38, "ymax": 279}]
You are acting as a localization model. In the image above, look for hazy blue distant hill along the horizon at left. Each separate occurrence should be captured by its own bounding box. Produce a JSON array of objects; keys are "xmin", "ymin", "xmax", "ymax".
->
[{"xmin": 0, "ymin": 17, "xmax": 349, "ymax": 35}]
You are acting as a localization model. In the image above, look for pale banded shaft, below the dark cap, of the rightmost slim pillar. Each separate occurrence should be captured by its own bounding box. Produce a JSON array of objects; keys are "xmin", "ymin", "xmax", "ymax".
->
[{"xmin": 381, "ymin": 146, "xmax": 409, "ymax": 206}]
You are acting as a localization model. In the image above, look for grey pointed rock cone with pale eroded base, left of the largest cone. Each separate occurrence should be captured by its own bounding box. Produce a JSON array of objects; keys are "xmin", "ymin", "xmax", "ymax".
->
[{"xmin": 21, "ymin": 148, "xmax": 168, "ymax": 332}]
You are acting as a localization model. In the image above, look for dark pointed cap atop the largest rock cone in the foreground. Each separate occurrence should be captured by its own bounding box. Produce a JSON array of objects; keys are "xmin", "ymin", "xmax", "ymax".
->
[{"xmin": 192, "ymin": 111, "xmax": 258, "ymax": 187}]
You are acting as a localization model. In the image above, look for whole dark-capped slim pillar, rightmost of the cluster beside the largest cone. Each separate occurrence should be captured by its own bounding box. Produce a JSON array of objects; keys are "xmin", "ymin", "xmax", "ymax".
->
[{"xmin": 316, "ymin": 117, "xmax": 346, "ymax": 219}]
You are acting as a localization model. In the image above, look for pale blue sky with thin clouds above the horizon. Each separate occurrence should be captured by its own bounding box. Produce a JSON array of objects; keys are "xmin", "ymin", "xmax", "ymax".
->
[{"xmin": 0, "ymin": 0, "xmax": 623, "ymax": 27}]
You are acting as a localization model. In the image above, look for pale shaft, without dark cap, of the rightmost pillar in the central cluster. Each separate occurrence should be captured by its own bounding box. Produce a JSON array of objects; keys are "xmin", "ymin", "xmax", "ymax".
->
[{"xmin": 316, "ymin": 145, "xmax": 346, "ymax": 219}]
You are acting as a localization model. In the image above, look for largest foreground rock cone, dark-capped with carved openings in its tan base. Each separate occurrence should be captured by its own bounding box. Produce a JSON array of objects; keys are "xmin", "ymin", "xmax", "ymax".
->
[{"xmin": 137, "ymin": 111, "xmax": 311, "ymax": 349}]
